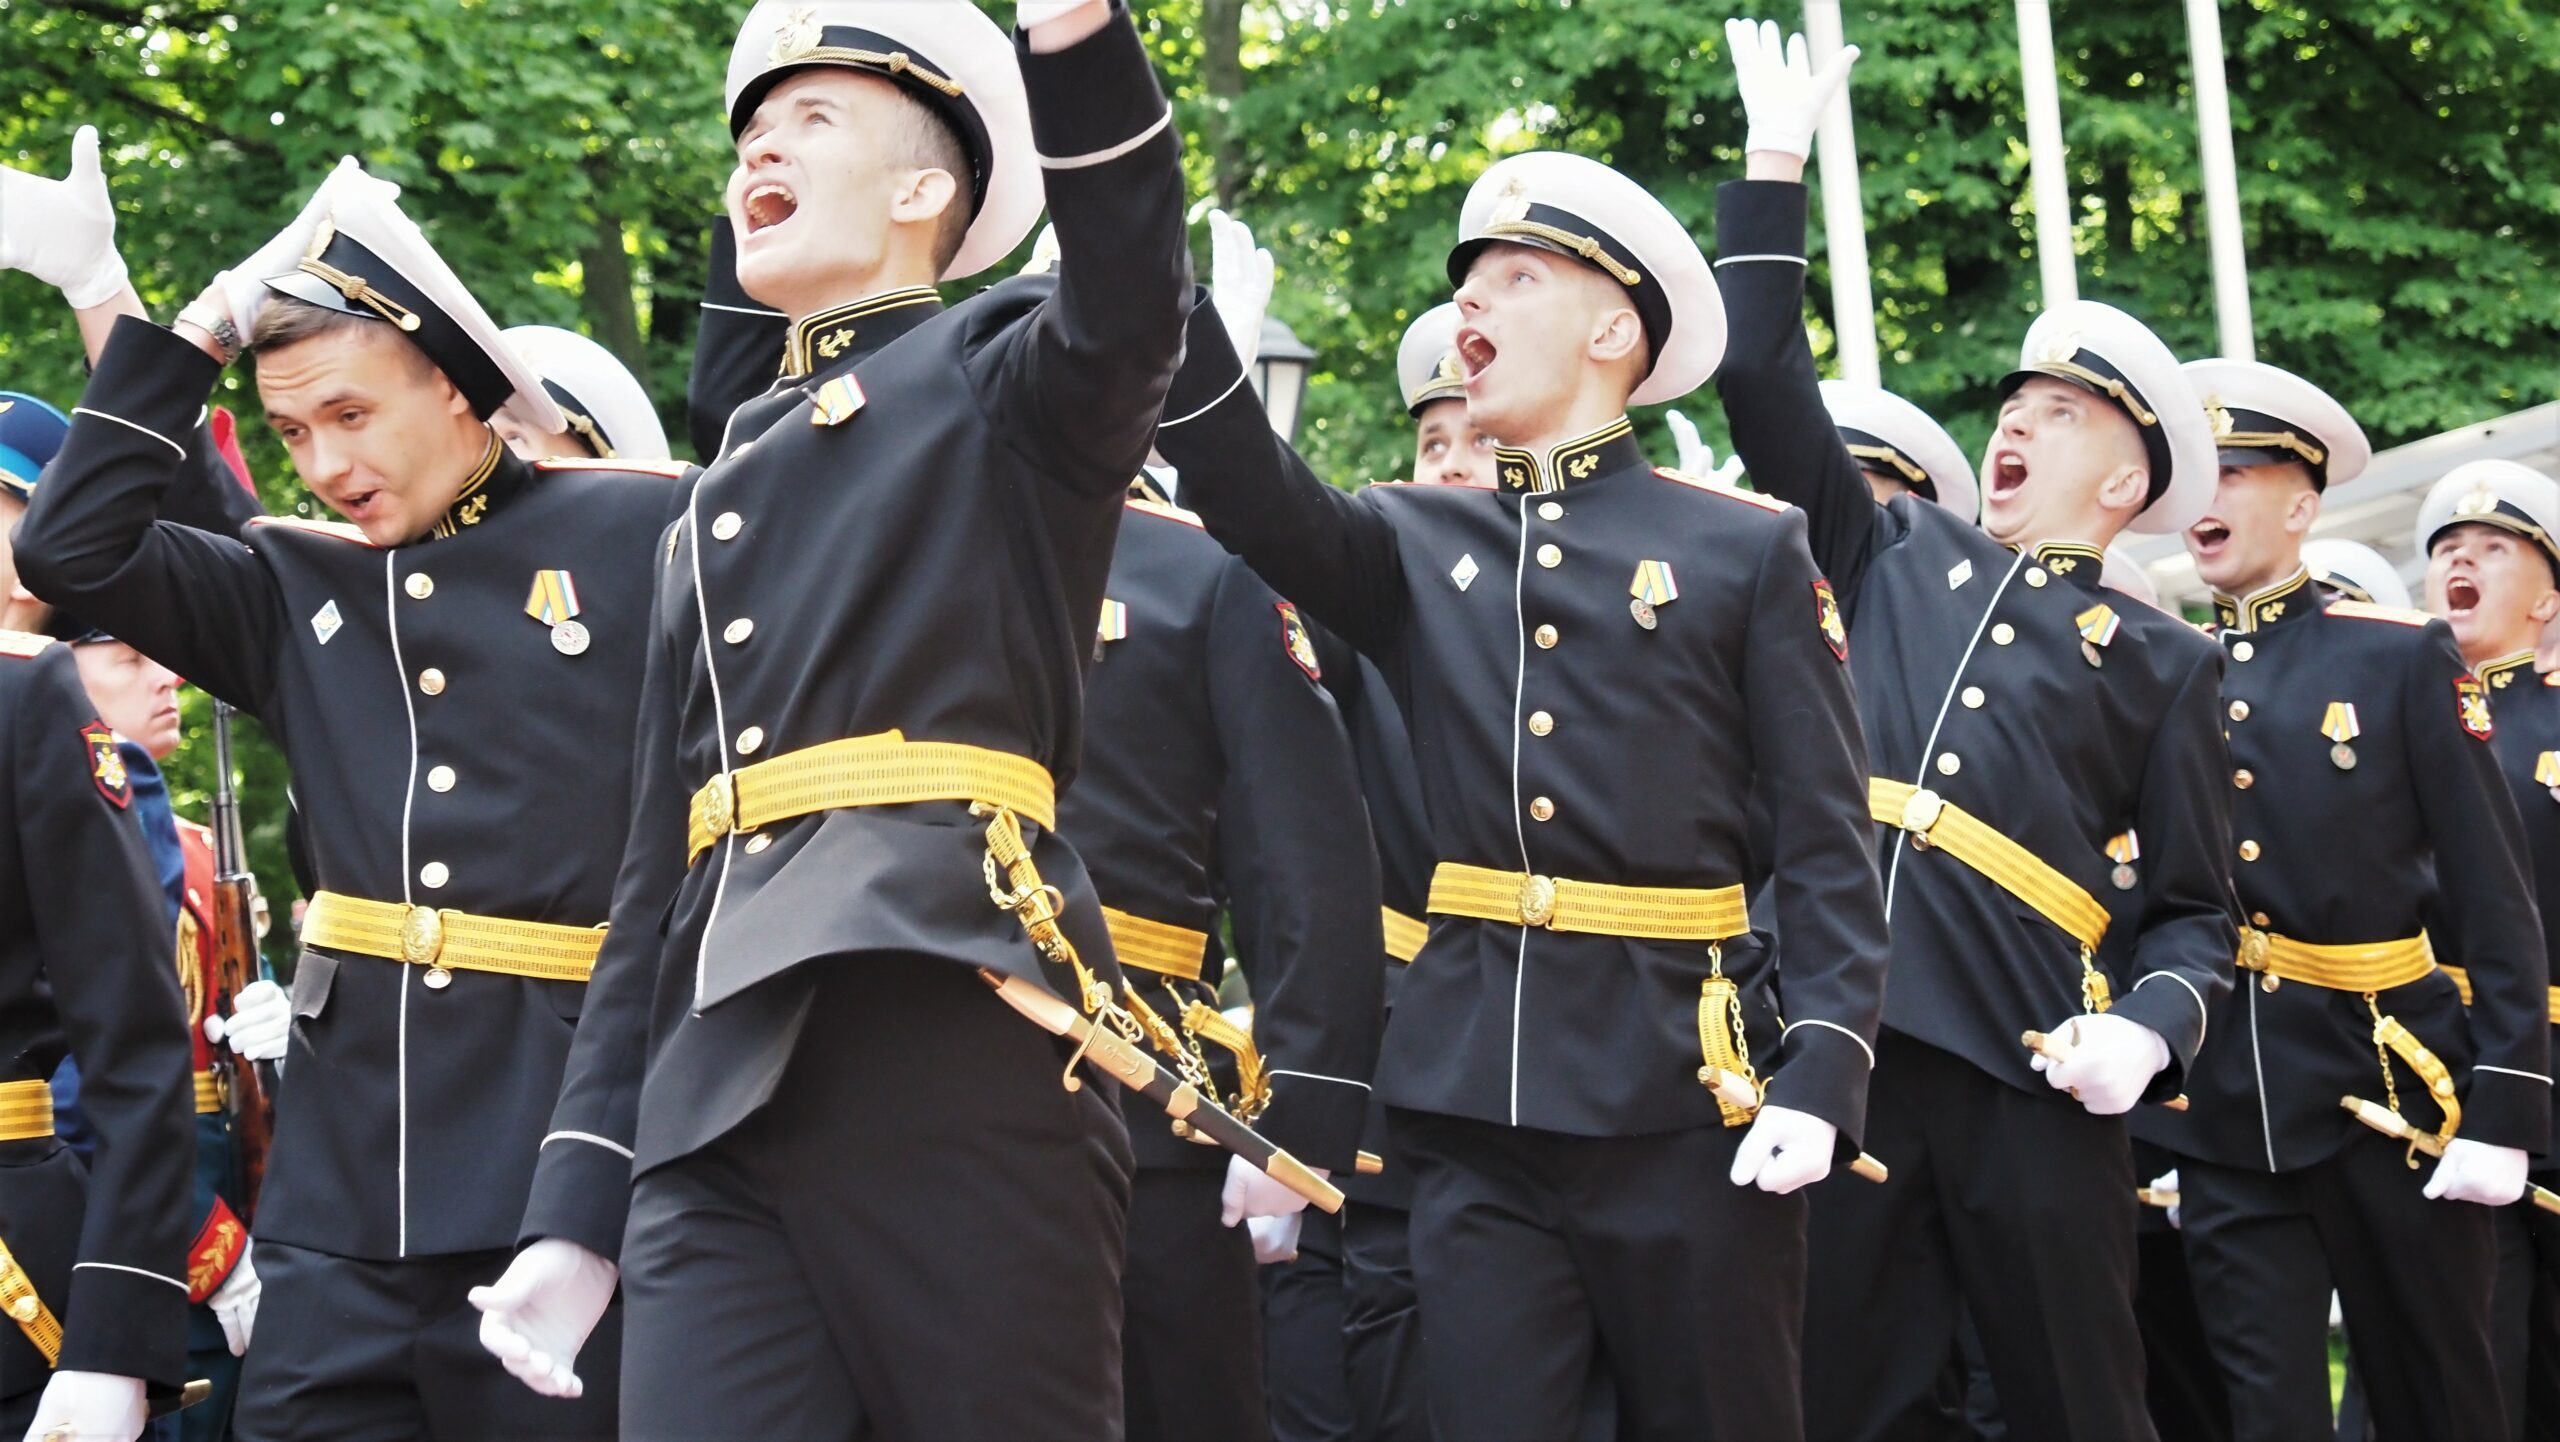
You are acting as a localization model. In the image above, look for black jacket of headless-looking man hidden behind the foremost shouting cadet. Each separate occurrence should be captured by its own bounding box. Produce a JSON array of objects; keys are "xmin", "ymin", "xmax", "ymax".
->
[{"xmin": 1057, "ymin": 499, "xmax": 1382, "ymax": 1173}]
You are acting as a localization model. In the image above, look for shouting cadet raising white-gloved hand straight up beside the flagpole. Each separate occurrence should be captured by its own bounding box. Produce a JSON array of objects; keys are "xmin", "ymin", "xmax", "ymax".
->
[{"xmin": 1715, "ymin": 26, "xmax": 2237, "ymax": 1439}]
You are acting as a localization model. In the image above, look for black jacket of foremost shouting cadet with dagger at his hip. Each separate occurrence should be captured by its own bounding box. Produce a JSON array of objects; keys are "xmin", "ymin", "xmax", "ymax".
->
[{"xmin": 525, "ymin": 5, "xmax": 1190, "ymax": 1255}]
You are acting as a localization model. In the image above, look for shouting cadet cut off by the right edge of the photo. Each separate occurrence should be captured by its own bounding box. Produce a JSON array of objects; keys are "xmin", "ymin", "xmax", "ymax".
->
[{"xmin": 2391, "ymin": 461, "xmax": 2560, "ymax": 1439}]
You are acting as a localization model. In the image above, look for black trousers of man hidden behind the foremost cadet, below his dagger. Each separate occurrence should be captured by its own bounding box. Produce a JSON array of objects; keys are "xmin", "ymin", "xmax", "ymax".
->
[{"xmin": 1121, "ymin": 1168, "xmax": 1272, "ymax": 1442}]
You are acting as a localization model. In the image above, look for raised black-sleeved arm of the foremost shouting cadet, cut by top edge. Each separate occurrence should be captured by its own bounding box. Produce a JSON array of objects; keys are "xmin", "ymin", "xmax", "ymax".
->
[{"xmin": 970, "ymin": 0, "xmax": 1190, "ymax": 494}]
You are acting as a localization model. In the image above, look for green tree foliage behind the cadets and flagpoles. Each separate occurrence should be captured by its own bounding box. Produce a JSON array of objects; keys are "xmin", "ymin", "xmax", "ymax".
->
[{"xmin": 0, "ymin": 0, "xmax": 2560, "ymax": 896}]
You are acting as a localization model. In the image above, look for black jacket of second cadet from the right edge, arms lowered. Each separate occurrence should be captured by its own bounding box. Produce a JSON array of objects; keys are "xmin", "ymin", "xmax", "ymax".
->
[{"xmin": 2140, "ymin": 586, "xmax": 2550, "ymax": 1171}]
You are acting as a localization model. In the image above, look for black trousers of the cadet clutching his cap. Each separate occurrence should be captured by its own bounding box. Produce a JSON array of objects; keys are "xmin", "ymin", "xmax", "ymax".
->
[{"xmin": 233, "ymin": 1242, "xmax": 622, "ymax": 1442}]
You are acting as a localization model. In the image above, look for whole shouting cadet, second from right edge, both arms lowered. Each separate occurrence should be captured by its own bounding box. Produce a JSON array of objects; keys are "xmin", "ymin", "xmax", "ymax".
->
[{"xmin": 2138, "ymin": 361, "xmax": 2550, "ymax": 1437}]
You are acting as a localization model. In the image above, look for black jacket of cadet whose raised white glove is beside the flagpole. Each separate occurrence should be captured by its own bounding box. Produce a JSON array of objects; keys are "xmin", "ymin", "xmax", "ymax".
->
[{"xmin": 1715, "ymin": 182, "xmax": 2242, "ymax": 1106}]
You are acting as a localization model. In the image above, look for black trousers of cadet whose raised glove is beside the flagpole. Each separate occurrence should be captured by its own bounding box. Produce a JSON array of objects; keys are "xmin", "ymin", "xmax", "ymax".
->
[{"xmin": 1805, "ymin": 1032, "xmax": 2153, "ymax": 1442}]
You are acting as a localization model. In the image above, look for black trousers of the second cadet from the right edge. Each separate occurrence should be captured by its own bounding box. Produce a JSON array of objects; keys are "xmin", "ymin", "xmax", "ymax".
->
[{"xmin": 2179, "ymin": 1135, "xmax": 2506, "ymax": 1442}]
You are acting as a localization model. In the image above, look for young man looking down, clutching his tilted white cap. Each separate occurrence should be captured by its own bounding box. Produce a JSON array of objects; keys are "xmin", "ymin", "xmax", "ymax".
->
[{"xmin": 18, "ymin": 164, "xmax": 678, "ymax": 1439}]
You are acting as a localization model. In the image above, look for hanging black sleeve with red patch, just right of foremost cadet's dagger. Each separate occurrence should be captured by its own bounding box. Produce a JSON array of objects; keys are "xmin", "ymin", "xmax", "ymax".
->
[{"xmin": 1208, "ymin": 561, "xmax": 1385, "ymax": 1171}]
